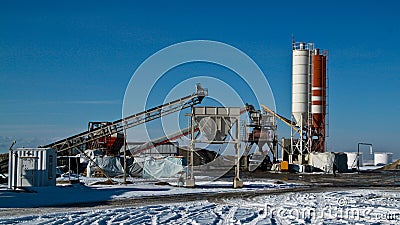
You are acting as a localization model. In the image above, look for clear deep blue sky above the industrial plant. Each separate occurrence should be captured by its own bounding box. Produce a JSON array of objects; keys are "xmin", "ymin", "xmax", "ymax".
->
[{"xmin": 0, "ymin": 1, "xmax": 400, "ymax": 157}]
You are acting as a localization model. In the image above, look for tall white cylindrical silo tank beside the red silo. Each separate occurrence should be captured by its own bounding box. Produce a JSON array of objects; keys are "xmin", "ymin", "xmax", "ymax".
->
[{"xmin": 292, "ymin": 43, "xmax": 311, "ymax": 125}]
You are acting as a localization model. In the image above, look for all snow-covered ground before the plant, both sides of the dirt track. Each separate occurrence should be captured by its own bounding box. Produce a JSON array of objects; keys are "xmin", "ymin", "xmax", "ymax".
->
[{"xmin": 0, "ymin": 180, "xmax": 400, "ymax": 224}]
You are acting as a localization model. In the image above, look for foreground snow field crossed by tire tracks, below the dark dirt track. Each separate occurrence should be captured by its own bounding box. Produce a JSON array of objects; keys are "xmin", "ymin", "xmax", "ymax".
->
[{"xmin": 0, "ymin": 190, "xmax": 400, "ymax": 224}]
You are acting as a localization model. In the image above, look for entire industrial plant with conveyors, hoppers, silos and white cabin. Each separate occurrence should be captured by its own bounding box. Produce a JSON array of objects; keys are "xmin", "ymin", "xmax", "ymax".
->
[{"xmin": 0, "ymin": 40, "xmax": 392, "ymax": 188}]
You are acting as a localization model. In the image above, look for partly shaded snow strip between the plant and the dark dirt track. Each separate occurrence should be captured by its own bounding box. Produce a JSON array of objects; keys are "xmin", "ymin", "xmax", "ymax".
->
[{"xmin": 0, "ymin": 178, "xmax": 299, "ymax": 208}]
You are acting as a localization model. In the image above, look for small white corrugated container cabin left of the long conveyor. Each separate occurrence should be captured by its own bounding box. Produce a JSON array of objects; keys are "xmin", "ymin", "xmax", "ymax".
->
[{"xmin": 8, "ymin": 148, "xmax": 57, "ymax": 189}]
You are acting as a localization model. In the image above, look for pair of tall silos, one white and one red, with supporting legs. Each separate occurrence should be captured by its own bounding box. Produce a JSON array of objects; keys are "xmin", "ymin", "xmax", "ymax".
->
[{"xmin": 289, "ymin": 41, "xmax": 327, "ymax": 164}]
